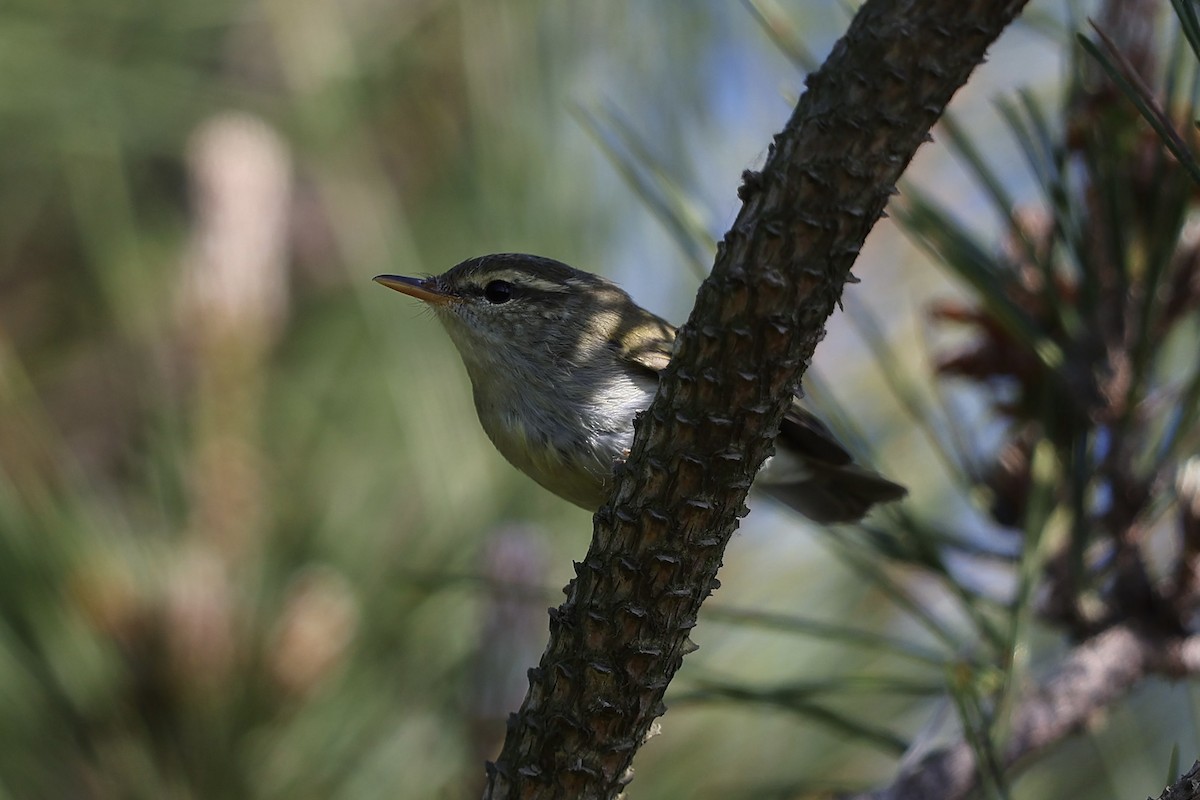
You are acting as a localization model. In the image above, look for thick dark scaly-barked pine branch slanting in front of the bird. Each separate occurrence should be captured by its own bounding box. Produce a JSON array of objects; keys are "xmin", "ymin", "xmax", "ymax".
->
[{"xmin": 484, "ymin": 0, "xmax": 1026, "ymax": 799}]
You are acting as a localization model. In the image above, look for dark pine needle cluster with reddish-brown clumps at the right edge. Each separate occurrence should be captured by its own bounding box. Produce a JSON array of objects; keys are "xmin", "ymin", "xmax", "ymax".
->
[{"xmin": 883, "ymin": 0, "xmax": 1200, "ymax": 798}]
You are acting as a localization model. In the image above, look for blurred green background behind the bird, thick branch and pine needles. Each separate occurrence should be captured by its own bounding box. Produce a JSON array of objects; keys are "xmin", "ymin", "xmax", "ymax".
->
[{"xmin": 0, "ymin": 0, "xmax": 1196, "ymax": 799}]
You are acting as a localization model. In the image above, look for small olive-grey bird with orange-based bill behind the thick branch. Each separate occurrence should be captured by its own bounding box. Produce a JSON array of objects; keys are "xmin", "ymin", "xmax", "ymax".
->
[{"xmin": 374, "ymin": 253, "xmax": 907, "ymax": 524}]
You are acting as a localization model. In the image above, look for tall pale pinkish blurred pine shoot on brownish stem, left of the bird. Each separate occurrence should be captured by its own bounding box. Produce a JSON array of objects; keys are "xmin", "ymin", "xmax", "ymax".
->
[{"xmin": 179, "ymin": 113, "xmax": 292, "ymax": 563}]
